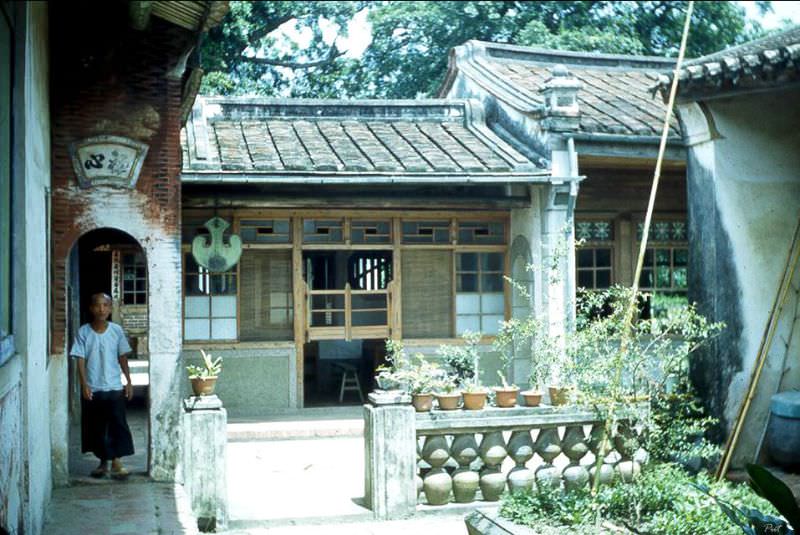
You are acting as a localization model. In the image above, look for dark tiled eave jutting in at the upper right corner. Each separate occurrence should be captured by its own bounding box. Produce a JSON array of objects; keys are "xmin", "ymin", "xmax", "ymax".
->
[{"xmin": 657, "ymin": 26, "xmax": 800, "ymax": 98}]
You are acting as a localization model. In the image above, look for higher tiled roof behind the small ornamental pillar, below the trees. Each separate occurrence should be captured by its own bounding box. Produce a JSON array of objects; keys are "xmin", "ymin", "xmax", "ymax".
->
[{"xmin": 439, "ymin": 41, "xmax": 680, "ymax": 137}]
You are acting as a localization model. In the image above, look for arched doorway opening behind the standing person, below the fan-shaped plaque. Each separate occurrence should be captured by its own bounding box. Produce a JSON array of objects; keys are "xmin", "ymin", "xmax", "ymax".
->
[{"xmin": 67, "ymin": 228, "xmax": 150, "ymax": 479}]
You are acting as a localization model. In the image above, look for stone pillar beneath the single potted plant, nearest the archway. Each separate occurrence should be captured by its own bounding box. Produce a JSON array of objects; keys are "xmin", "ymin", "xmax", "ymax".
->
[{"xmin": 183, "ymin": 395, "xmax": 228, "ymax": 531}]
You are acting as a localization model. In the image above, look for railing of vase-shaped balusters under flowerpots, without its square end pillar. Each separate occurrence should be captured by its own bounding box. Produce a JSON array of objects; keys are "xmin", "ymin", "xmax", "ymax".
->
[{"xmin": 415, "ymin": 407, "xmax": 646, "ymax": 505}]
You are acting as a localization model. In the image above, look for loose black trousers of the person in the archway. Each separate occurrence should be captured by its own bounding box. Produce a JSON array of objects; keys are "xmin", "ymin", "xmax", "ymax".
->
[{"xmin": 81, "ymin": 390, "xmax": 133, "ymax": 461}]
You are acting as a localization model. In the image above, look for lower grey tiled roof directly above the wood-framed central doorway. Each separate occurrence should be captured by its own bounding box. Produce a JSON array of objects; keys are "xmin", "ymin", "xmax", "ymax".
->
[{"xmin": 182, "ymin": 97, "xmax": 546, "ymax": 181}]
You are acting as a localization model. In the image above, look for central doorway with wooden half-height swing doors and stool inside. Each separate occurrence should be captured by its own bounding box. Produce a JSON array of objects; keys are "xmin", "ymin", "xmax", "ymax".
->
[{"xmin": 303, "ymin": 250, "xmax": 393, "ymax": 407}]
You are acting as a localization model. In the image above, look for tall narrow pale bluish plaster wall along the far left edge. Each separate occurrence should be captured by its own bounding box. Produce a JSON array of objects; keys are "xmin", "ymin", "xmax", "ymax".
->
[{"xmin": 0, "ymin": 3, "xmax": 51, "ymax": 534}]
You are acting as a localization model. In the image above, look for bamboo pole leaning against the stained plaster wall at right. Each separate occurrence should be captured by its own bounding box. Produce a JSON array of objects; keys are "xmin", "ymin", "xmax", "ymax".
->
[{"xmin": 717, "ymin": 216, "xmax": 800, "ymax": 481}]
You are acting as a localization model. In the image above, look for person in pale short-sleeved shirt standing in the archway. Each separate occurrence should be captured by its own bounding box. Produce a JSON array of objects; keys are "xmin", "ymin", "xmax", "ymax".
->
[{"xmin": 70, "ymin": 293, "xmax": 133, "ymax": 479}]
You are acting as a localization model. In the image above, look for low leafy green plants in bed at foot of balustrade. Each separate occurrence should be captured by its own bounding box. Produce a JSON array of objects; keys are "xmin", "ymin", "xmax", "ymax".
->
[{"xmin": 500, "ymin": 463, "xmax": 773, "ymax": 535}]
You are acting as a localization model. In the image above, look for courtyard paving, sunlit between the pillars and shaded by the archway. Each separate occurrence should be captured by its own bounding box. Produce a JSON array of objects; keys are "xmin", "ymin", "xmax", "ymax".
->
[{"xmin": 44, "ymin": 407, "xmax": 466, "ymax": 535}]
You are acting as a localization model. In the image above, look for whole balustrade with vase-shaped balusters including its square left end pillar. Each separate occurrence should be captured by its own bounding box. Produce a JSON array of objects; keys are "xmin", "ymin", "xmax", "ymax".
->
[{"xmin": 365, "ymin": 394, "xmax": 647, "ymax": 518}]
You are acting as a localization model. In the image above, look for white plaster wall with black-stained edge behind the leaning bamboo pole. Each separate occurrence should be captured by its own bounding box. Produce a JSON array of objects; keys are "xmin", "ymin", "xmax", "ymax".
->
[{"xmin": 681, "ymin": 89, "xmax": 800, "ymax": 464}]
